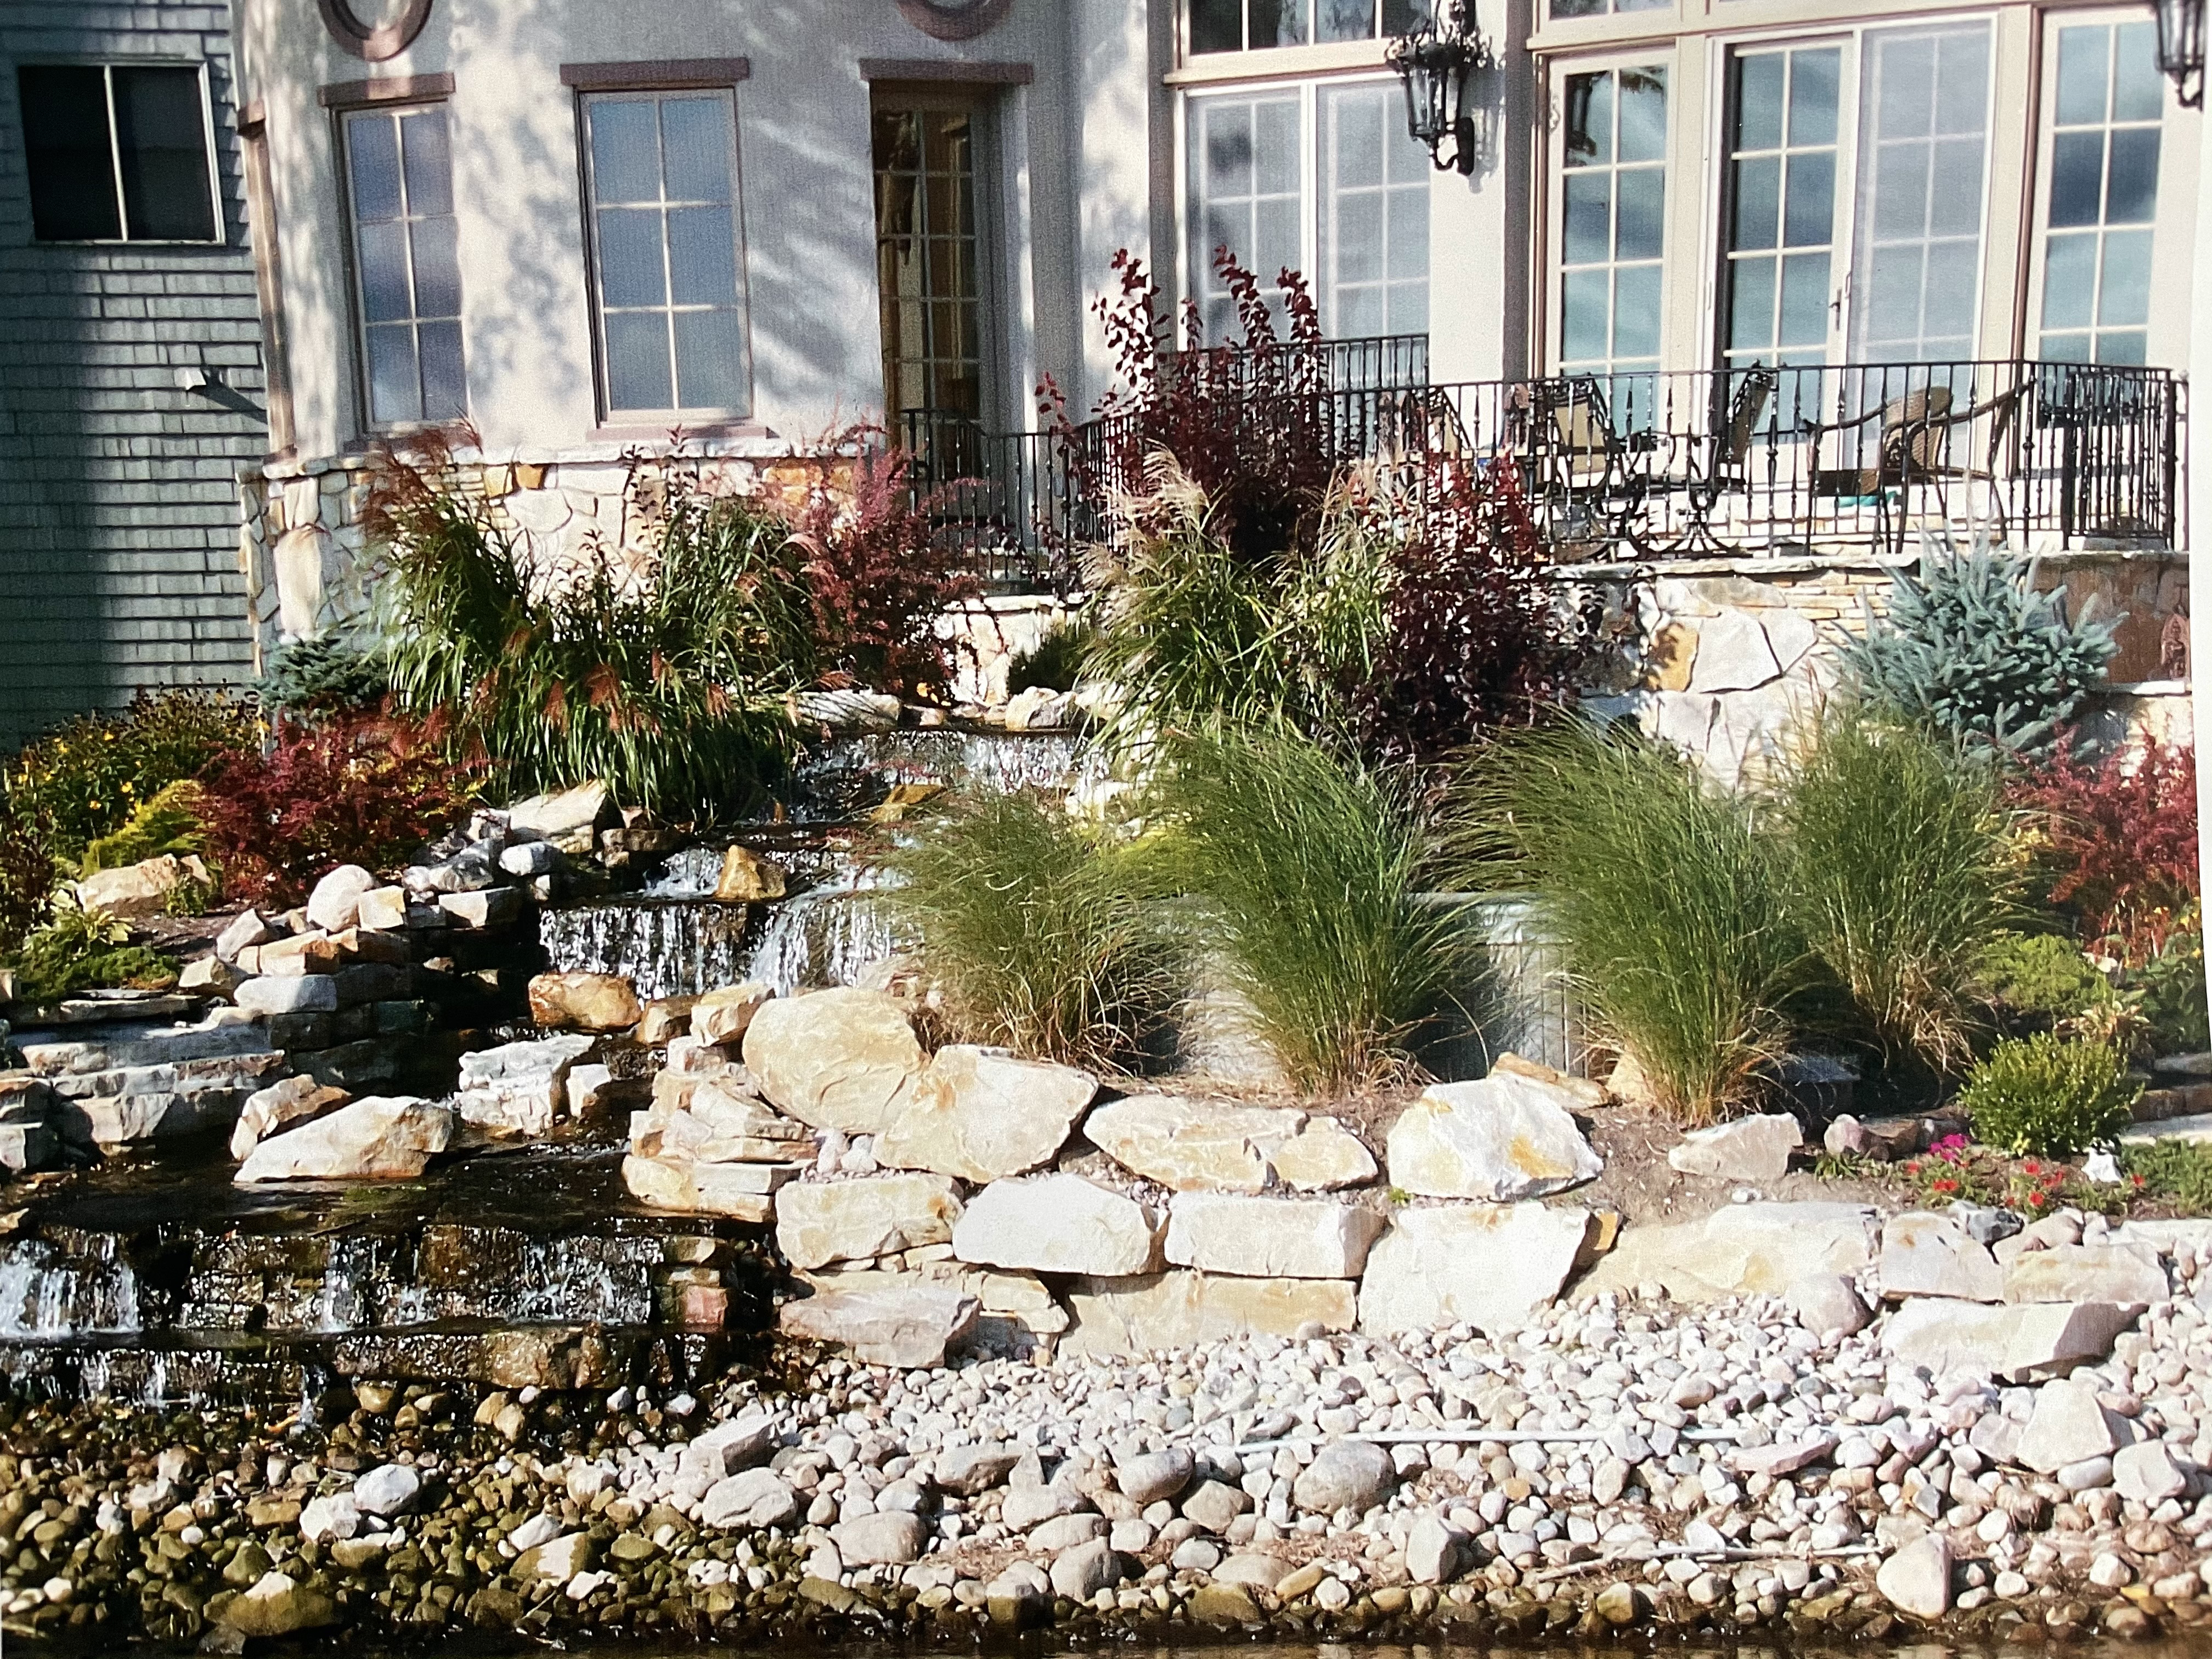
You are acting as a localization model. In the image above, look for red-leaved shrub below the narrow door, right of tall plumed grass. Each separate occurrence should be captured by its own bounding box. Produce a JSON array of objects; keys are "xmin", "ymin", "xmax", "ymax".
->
[{"xmin": 792, "ymin": 447, "xmax": 980, "ymax": 692}]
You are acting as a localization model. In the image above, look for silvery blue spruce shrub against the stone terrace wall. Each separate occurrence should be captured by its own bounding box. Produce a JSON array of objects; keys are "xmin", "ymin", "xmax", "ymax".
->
[{"xmin": 1843, "ymin": 535, "xmax": 2117, "ymax": 757}]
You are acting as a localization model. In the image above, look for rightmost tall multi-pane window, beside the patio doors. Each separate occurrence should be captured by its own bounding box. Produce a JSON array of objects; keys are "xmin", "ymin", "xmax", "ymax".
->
[{"xmin": 2042, "ymin": 18, "xmax": 2163, "ymax": 363}]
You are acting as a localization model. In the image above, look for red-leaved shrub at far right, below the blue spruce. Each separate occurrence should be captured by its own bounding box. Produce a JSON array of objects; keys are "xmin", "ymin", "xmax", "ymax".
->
[{"xmin": 2011, "ymin": 739, "xmax": 2199, "ymax": 967}]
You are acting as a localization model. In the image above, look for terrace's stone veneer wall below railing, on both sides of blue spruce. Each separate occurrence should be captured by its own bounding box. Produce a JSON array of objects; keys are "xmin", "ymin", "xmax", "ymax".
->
[{"xmin": 1560, "ymin": 553, "xmax": 2192, "ymax": 781}]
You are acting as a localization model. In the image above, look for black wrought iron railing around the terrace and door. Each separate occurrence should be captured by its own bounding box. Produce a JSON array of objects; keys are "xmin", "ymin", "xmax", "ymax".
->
[{"xmin": 905, "ymin": 343, "xmax": 2186, "ymax": 584}]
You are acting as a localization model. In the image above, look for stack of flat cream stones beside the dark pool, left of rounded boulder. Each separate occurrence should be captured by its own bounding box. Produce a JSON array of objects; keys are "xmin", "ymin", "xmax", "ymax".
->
[{"xmin": 622, "ymin": 984, "xmax": 816, "ymax": 1226}]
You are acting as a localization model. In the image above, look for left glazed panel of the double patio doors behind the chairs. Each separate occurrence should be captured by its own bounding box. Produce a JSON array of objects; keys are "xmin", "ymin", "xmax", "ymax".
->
[{"xmin": 1721, "ymin": 47, "xmax": 1843, "ymax": 367}]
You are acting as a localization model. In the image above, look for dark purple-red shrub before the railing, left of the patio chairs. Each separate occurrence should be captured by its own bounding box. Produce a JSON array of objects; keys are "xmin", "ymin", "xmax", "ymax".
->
[{"xmin": 1352, "ymin": 458, "xmax": 1577, "ymax": 763}]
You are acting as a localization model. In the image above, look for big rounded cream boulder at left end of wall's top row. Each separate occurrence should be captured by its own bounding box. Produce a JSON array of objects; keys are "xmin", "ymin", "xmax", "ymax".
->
[{"xmin": 746, "ymin": 989, "xmax": 922, "ymax": 1135}]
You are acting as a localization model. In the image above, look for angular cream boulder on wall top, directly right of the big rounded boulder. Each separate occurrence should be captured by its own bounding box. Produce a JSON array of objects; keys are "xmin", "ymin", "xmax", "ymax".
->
[{"xmin": 876, "ymin": 1044, "xmax": 1099, "ymax": 1181}]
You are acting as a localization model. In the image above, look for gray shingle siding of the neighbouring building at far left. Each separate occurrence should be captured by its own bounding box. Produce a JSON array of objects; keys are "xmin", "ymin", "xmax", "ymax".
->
[{"xmin": 0, "ymin": 0, "xmax": 268, "ymax": 748}]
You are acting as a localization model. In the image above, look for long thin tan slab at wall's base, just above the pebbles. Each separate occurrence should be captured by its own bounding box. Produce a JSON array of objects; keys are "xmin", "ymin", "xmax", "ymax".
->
[{"xmin": 1059, "ymin": 1269, "xmax": 1358, "ymax": 1354}]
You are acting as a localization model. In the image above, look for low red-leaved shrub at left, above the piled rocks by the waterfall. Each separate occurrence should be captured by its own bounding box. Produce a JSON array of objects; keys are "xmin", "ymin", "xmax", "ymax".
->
[{"xmin": 201, "ymin": 712, "xmax": 471, "ymax": 905}]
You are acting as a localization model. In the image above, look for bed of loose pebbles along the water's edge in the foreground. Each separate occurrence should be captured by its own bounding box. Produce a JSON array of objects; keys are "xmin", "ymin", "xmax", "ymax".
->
[{"xmin": 13, "ymin": 1294, "xmax": 2212, "ymax": 1650}]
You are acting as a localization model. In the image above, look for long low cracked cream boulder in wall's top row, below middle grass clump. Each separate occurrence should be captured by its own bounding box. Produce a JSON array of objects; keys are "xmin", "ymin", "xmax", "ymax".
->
[{"xmin": 1084, "ymin": 1095, "xmax": 1376, "ymax": 1192}]
